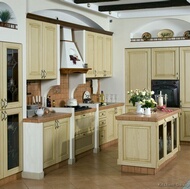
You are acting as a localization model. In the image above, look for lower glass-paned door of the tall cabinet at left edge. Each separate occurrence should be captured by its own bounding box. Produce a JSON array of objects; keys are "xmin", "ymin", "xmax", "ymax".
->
[{"xmin": 0, "ymin": 108, "xmax": 23, "ymax": 179}]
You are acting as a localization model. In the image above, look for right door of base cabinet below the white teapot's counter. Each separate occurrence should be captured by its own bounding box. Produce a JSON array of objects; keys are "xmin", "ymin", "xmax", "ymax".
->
[{"xmin": 56, "ymin": 119, "xmax": 69, "ymax": 163}]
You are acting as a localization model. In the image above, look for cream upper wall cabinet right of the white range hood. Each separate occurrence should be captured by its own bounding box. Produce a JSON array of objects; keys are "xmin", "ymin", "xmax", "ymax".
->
[{"xmin": 74, "ymin": 31, "xmax": 112, "ymax": 78}]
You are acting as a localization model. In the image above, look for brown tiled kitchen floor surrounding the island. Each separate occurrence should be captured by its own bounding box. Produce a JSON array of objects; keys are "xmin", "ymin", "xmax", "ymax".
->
[{"xmin": 0, "ymin": 145, "xmax": 190, "ymax": 189}]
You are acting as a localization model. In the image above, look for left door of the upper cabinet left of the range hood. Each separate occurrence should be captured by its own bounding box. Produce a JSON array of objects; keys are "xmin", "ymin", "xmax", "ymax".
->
[{"xmin": 26, "ymin": 19, "xmax": 43, "ymax": 79}]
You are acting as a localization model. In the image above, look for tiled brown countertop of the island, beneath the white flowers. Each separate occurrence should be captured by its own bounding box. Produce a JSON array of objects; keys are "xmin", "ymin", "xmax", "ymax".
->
[{"xmin": 116, "ymin": 108, "xmax": 181, "ymax": 122}]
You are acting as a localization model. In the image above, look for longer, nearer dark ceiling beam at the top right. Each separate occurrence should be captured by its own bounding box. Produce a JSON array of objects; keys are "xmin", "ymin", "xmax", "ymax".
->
[{"xmin": 98, "ymin": 0, "xmax": 190, "ymax": 12}]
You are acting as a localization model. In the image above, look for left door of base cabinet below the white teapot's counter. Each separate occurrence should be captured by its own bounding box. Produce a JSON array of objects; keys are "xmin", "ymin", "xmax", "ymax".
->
[{"xmin": 43, "ymin": 121, "xmax": 56, "ymax": 168}]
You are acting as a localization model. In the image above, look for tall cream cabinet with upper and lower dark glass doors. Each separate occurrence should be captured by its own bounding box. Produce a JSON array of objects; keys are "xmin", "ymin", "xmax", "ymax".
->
[{"xmin": 0, "ymin": 42, "xmax": 23, "ymax": 179}]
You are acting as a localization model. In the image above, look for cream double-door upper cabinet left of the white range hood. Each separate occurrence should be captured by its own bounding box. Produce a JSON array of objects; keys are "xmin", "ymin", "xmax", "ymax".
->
[{"xmin": 26, "ymin": 19, "xmax": 57, "ymax": 80}]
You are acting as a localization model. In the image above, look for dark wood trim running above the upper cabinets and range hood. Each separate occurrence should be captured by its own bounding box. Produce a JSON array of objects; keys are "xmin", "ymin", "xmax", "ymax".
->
[{"xmin": 26, "ymin": 13, "xmax": 113, "ymax": 35}]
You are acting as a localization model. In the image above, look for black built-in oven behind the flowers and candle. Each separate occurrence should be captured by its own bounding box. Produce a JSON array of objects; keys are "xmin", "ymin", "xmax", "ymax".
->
[{"xmin": 151, "ymin": 80, "xmax": 180, "ymax": 107}]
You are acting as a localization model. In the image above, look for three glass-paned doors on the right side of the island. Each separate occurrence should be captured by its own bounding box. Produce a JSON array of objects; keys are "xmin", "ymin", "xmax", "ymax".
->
[{"xmin": 158, "ymin": 114, "xmax": 179, "ymax": 165}]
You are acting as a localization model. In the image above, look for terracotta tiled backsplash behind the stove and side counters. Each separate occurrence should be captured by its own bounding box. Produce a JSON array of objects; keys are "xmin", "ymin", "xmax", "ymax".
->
[{"xmin": 27, "ymin": 75, "xmax": 99, "ymax": 107}]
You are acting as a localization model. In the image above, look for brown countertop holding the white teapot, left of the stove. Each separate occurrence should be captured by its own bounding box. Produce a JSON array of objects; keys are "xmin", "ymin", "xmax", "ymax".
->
[{"xmin": 23, "ymin": 113, "xmax": 72, "ymax": 123}]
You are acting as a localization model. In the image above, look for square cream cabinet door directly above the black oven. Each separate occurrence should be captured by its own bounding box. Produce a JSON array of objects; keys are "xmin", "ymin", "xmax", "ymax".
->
[{"xmin": 152, "ymin": 48, "xmax": 179, "ymax": 79}]
